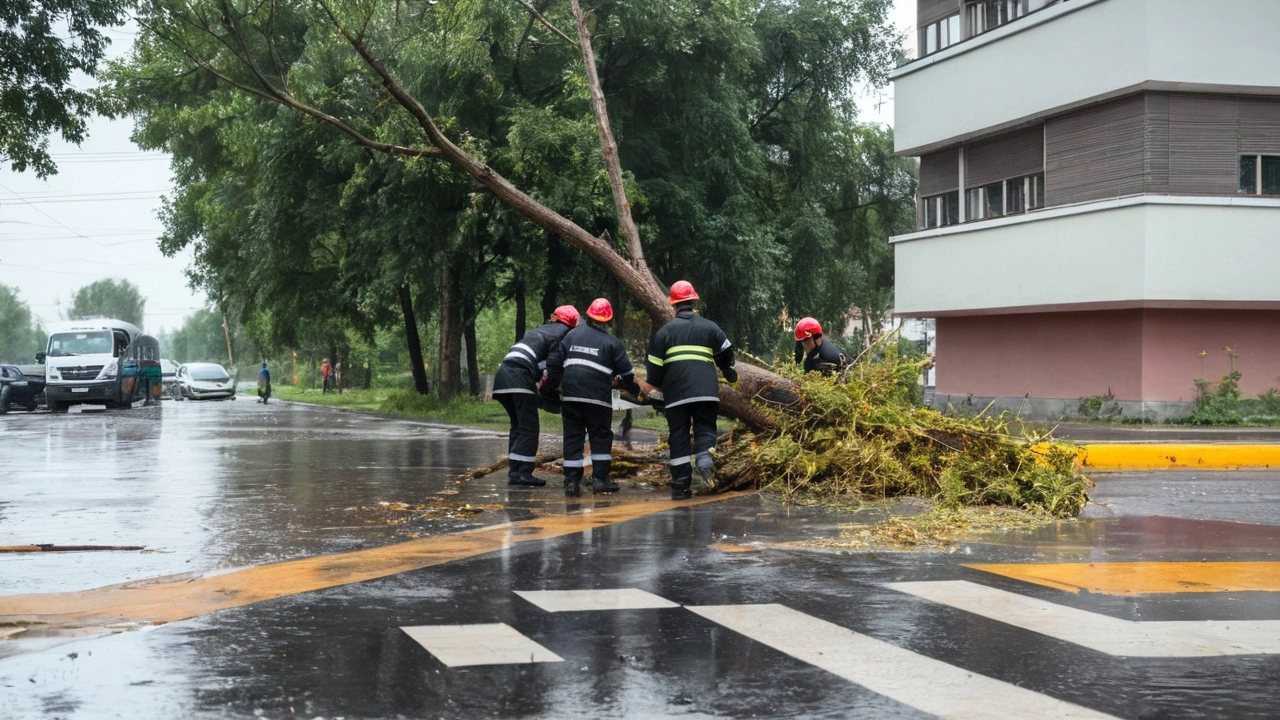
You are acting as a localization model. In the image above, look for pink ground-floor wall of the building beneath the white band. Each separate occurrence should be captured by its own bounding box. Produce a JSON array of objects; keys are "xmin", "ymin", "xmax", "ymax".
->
[{"xmin": 937, "ymin": 309, "xmax": 1280, "ymax": 401}]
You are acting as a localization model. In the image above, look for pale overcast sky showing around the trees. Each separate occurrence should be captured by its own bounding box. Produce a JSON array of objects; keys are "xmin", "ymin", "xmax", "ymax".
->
[{"xmin": 0, "ymin": 0, "xmax": 915, "ymax": 333}]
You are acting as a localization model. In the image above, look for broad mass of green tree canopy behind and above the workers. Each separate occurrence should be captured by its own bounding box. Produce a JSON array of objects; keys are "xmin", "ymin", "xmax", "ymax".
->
[{"xmin": 111, "ymin": 0, "xmax": 914, "ymax": 404}]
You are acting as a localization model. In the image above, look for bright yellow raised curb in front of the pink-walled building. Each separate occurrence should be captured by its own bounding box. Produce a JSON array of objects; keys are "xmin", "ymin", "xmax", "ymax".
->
[{"xmin": 1079, "ymin": 443, "xmax": 1280, "ymax": 471}]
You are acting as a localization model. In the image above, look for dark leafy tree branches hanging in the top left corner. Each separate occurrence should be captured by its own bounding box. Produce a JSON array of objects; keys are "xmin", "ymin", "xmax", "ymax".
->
[{"xmin": 0, "ymin": 0, "xmax": 131, "ymax": 177}]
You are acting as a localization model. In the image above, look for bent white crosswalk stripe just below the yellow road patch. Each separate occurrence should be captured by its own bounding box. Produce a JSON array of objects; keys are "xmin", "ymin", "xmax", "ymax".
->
[{"xmin": 886, "ymin": 580, "xmax": 1280, "ymax": 657}]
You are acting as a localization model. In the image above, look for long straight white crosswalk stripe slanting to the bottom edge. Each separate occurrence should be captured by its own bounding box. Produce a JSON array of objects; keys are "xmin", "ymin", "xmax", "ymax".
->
[{"xmin": 689, "ymin": 605, "xmax": 1111, "ymax": 719}]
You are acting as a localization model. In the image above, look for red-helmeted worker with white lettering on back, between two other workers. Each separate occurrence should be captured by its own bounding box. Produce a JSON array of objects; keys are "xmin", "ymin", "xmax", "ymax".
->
[{"xmin": 548, "ymin": 297, "xmax": 640, "ymax": 497}]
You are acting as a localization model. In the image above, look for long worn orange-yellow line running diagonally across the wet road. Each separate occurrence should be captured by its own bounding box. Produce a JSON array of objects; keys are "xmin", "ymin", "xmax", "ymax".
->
[{"xmin": 0, "ymin": 493, "xmax": 748, "ymax": 634}]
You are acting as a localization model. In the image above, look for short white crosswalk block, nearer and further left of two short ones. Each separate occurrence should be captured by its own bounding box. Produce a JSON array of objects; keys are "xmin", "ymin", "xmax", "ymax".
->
[{"xmin": 401, "ymin": 623, "xmax": 564, "ymax": 667}]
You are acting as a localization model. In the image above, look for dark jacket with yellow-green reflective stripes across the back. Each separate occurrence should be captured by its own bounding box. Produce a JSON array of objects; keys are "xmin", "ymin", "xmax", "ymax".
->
[{"xmin": 645, "ymin": 310, "xmax": 733, "ymax": 407}]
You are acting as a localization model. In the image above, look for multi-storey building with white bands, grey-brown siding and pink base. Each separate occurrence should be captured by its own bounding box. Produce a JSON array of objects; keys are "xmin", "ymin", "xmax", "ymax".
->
[{"xmin": 892, "ymin": 0, "xmax": 1280, "ymax": 418}]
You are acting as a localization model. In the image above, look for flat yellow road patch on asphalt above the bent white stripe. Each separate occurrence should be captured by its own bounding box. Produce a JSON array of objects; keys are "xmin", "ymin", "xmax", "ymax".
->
[{"xmin": 965, "ymin": 562, "xmax": 1280, "ymax": 596}]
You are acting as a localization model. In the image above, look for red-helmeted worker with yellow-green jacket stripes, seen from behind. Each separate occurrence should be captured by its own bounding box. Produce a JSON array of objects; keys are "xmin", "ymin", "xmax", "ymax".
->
[{"xmin": 645, "ymin": 281, "xmax": 737, "ymax": 500}]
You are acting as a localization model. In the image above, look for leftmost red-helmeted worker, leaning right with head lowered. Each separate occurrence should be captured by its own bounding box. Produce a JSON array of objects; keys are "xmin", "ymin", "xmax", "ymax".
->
[{"xmin": 493, "ymin": 305, "xmax": 577, "ymax": 487}]
